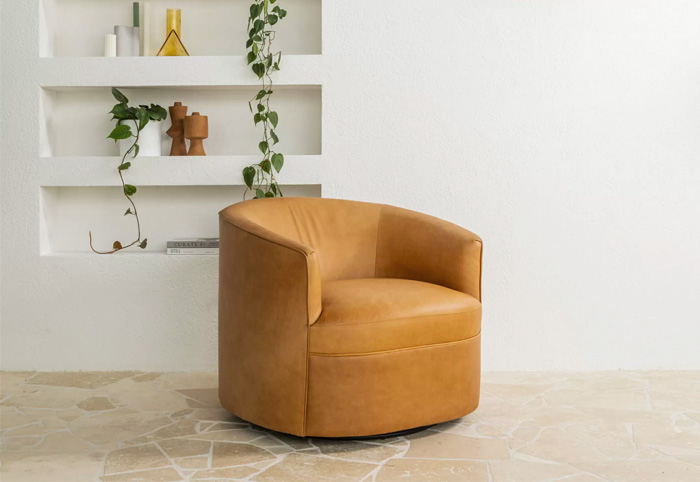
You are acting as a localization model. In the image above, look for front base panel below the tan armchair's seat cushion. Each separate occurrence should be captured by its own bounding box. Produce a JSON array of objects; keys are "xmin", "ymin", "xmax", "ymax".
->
[{"xmin": 304, "ymin": 334, "xmax": 481, "ymax": 438}]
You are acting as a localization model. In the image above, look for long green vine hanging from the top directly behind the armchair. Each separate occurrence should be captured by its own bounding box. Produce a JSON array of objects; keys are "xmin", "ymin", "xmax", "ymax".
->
[{"xmin": 243, "ymin": 0, "xmax": 287, "ymax": 199}]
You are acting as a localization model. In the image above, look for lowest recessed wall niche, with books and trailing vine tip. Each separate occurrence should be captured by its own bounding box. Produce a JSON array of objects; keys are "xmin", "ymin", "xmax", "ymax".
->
[{"xmin": 41, "ymin": 184, "xmax": 321, "ymax": 254}]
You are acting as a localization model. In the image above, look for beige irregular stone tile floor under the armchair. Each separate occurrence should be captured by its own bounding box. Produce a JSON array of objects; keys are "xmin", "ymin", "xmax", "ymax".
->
[{"xmin": 0, "ymin": 372, "xmax": 700, "ymax": 482}]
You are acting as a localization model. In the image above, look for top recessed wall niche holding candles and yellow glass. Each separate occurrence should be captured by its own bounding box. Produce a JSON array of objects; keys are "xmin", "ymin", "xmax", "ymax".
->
[{"xmin": 40, "ymin": 0, "xmax": 322, "ymax": 57}]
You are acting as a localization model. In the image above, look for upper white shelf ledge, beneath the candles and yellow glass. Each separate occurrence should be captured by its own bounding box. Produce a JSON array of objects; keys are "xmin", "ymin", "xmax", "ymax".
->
[{"xmin": 39, "ymin": 55, "xmax": 323, "ymax": 90}]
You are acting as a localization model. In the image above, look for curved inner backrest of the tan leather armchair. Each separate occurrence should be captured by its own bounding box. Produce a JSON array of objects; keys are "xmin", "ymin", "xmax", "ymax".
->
[{"xmin": 220, "ymin": 197, "xmax": 382, "ymax": 281}]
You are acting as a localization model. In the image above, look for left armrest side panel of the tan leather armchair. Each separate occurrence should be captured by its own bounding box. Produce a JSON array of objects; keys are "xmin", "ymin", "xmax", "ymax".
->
[{"xmin": 219, "ymin": 206, "xmax": 321, "ymax": 436}]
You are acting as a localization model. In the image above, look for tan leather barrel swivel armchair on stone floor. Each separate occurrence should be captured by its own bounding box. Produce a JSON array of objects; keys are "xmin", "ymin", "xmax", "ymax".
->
[{"xmin": 219, "ymin": 198, "xmax": 482, "ymax": 437}]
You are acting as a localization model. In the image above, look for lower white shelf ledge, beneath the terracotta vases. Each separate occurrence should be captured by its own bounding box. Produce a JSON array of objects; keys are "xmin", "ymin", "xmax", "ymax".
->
[{"xmin": 39, "ymin": 155, "xmax": 324, "ymax": 187}]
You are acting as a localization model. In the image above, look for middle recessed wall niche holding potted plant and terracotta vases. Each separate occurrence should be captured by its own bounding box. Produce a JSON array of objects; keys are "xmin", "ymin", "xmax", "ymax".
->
[{"xmin": 40, "ymin": 85, "xmax": 321, "ymax": 157}]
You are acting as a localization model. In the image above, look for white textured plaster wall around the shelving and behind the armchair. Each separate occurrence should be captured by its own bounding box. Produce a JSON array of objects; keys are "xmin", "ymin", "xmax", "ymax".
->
[{"xmin": 0, "ymin": 0, "xmax": 700, "ymax": 370}]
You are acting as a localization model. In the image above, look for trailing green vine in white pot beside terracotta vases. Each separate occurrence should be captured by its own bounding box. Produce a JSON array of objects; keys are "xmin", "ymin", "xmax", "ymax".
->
[{"xmin": 90, "ymin": 88, "xmax": 168, "ymax": 254}]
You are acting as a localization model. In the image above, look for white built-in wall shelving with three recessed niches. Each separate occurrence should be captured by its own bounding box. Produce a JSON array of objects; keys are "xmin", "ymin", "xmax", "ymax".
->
[{"xmin": 35, "ymin": 0, "xmax": 329, "ymax": 260}]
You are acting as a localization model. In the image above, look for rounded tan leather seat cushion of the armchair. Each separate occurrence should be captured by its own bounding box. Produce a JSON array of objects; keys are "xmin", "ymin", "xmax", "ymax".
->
[{"xmin": 309, "ymin": 278, "xmax": 481, "ymax": 355}]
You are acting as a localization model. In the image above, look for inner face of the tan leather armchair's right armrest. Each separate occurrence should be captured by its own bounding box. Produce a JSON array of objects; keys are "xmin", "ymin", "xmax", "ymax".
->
[{"xmin": 375, "ymin": 206, "xmax": 483, "ymax": 301}]
